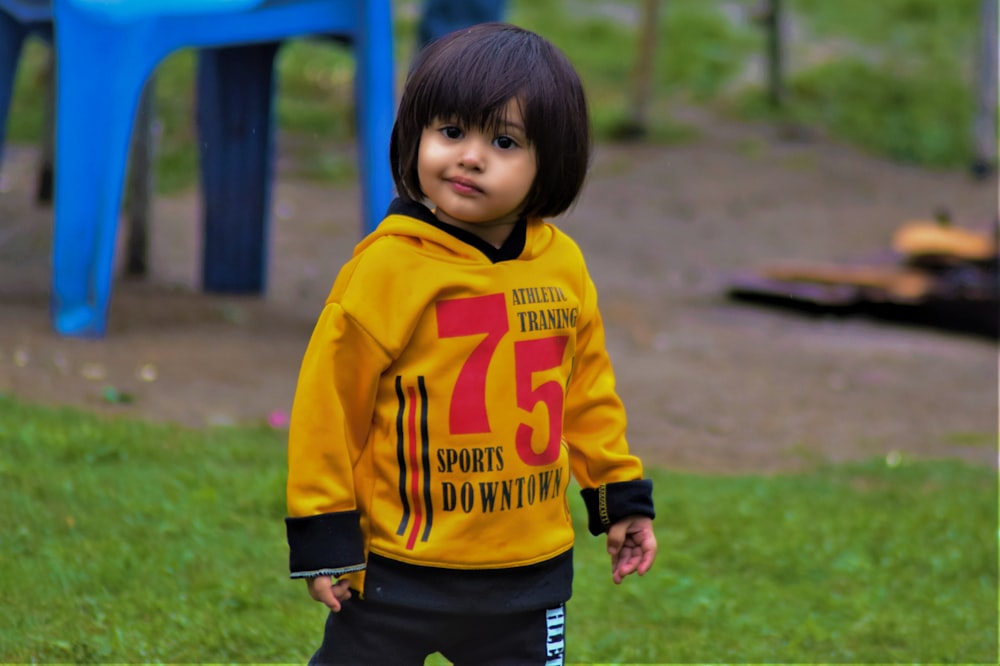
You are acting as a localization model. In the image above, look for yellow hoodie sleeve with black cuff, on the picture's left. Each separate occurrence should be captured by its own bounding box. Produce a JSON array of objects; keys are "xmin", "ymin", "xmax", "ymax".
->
[{"xmin": 285, "ymin": 302, "xmax": 389, "ymax": 578}]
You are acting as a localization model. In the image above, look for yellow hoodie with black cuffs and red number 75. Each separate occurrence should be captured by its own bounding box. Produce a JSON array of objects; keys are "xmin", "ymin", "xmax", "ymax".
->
[{"xmin": 286, "ymin": 200, "xmax": 653, "ymax": 610}]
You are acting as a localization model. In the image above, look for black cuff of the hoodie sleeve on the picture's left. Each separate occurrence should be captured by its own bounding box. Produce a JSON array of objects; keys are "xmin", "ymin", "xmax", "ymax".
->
[{"xmin": 285, "ymin": 511, "xmax": 365, "ymax": 578}]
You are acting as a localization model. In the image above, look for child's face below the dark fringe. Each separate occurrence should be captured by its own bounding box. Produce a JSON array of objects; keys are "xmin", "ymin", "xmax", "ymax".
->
[{"xmin": 417, "ymin": 100, "xmax": 537, "ymax": 245}]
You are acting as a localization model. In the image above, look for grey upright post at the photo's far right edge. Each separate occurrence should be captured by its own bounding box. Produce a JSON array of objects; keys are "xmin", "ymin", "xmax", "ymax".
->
[{"xmin": 972, "ymin": 0, "xmax": 1000, "ymax": 178}]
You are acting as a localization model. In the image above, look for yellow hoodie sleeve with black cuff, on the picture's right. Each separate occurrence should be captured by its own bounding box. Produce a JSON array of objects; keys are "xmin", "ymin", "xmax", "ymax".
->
[{"xmin": 563, "ymin": 276, "xmax": 655, "ymax": 535}]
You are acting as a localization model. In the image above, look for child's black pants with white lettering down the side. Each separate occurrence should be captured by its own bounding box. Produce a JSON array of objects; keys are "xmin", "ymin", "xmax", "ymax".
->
[{"xmin": 309, "ymin": 597, "xmax": 566, "ymax": 666}]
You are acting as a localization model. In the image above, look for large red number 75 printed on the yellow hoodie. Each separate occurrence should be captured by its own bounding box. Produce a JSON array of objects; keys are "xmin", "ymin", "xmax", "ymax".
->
[{"xmin": 437, "ymin": 294, "xmax": 568, "ymax": 465}]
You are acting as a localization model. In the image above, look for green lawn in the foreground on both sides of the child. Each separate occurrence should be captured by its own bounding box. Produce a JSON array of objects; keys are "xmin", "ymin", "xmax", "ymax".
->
[{"xmin": 0, "ymin": 398, "xmax": 997, "ymax": 663}]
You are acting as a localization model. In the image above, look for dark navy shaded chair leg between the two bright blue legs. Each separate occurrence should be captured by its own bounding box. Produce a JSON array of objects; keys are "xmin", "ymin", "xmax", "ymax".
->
[{"xmin": 197, "ymin": 43, "xmax": 279, "ymax": 293}]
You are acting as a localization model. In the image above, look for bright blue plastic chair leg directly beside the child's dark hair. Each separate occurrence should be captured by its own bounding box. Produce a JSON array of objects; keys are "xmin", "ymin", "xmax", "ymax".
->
[{"xmin": 354, "ymin": 2, "xmax": 396, "ymax": 234}]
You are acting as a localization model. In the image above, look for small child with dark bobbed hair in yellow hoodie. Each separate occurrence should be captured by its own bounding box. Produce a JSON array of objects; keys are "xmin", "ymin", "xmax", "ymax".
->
[{"xmin": 286, "ymin": 23, "xmax": 656, "ymax": 664}]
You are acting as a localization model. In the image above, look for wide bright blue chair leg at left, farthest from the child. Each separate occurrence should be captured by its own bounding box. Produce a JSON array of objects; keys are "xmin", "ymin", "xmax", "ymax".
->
[{"xmin": 52, "ymin": 10, "xmax": 148, "ymax": 337}]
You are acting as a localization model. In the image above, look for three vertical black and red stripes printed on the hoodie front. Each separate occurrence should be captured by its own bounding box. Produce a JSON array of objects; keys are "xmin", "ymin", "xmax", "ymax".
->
[{"xmin": 395, "ymin": 376, "xmax": 434, "ymax": 550}]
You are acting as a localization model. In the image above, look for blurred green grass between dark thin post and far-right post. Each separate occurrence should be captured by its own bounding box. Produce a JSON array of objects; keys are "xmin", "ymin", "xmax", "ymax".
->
[{"xmin": 729, "ymin": 0, "xmax": 979, "ymax": 168}]
